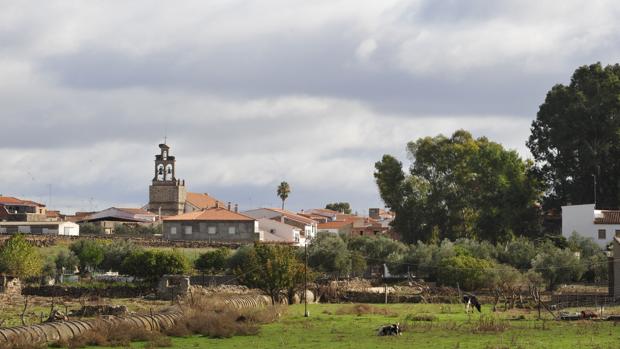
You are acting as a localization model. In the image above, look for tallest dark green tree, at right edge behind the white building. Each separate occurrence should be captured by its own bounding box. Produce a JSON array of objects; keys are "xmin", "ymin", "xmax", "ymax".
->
[{"xmin": 527, "ymin": 63, "xmax": 620, "ymax": 208}]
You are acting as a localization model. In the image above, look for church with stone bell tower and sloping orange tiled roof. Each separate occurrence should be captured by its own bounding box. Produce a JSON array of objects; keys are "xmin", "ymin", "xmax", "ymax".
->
[{"xmin": 147, "ymin": 144, "xmax": 230, "ymax": 216}]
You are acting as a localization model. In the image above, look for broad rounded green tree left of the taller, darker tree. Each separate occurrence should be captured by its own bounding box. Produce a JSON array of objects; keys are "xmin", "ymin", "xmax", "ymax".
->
[{"xmin": 375, "ymin": 130, "xmax": 540, "ymax": 242}]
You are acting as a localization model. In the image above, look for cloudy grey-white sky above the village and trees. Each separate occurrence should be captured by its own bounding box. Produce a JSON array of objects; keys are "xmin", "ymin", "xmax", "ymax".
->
[{"xmin": 0, "ymin": 0, "xmax": 620, "ymax": 214}]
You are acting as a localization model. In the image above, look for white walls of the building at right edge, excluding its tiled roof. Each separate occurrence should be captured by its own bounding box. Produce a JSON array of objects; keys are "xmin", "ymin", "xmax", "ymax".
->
[{"xmin": 562, "ymin": 204, "xmax": 620, "ymax": 247}]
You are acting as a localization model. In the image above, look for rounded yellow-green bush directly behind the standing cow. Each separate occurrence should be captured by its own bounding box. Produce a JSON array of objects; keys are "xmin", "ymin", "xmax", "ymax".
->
[{"xmin": 437, "ymin": 255, "xmax": 493, "ymax": 291}]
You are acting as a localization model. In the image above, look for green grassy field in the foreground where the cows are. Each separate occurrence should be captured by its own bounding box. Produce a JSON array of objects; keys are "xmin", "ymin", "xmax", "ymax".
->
[{"xmin": 83, "ymin": 304, "xmax": 620, "ymax": 349}]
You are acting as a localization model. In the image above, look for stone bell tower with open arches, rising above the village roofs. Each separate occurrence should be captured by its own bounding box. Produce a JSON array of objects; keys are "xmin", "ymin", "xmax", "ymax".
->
[{"xmin": 148, "ymin": 144, "xmax": 187, "ymax": 216}]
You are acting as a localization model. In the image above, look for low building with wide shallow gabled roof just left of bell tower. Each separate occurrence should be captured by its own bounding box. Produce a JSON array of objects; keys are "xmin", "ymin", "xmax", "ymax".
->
[{"xmin": 77, "ymin": 207, "xmax": 157, "ymax": 234}]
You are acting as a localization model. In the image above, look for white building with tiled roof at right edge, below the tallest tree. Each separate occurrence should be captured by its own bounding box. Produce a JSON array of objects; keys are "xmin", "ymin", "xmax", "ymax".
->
[{"xmin": 562, "ymin": 204, "xmax": 620, "ymax": 247}]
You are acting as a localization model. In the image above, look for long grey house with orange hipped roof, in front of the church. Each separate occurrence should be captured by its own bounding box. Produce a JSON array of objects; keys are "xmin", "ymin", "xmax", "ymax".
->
[{"xmin": 163, "ymin": 207, "xmax": 259, "ymax": 242}]
